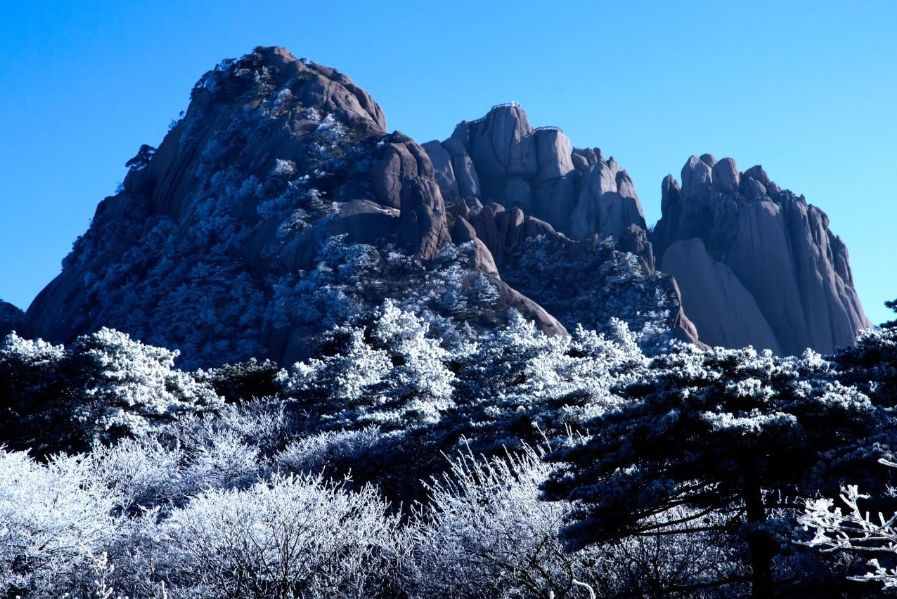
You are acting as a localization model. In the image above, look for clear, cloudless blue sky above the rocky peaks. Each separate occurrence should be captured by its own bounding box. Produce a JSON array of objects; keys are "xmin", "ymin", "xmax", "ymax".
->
[{"xmin": 0, "ymin": 0, "xmax": 897, "ymax": 322}]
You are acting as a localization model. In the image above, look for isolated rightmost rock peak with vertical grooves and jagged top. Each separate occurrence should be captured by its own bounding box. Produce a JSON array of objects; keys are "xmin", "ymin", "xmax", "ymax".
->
[{"xmin": 652, "ymin": 154, "xmax": 869, "ymax": 354}]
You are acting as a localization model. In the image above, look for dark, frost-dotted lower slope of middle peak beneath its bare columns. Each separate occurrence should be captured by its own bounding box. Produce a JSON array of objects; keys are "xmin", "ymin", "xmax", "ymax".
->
[{"xmin": 451, "ymin": 203, "xmax": 699, "ymax": 350}]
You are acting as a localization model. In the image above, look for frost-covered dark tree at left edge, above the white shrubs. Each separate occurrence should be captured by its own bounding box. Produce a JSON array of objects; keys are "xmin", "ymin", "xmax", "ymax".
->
[{"xmin": 0, "ymin": 329, "xmax": 224, "ymax": 455}]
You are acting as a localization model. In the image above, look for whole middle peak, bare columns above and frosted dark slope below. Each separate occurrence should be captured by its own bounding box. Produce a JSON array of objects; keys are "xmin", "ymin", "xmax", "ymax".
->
[{"xmin": 423, "ymin": 104, "xmax": 698, "ymax": 341}]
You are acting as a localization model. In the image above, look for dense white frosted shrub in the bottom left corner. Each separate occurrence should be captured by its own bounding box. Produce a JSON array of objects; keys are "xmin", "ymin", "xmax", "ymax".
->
[{"xmin": 0, "ymin": 450, "xmax": 118, "ymax": 597}]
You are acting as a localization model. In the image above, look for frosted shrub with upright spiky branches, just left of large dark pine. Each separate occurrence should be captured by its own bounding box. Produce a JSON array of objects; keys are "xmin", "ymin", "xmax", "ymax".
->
[{"xmin": 413, "ymin": 448, "xmax": 582, "ymax": 598}]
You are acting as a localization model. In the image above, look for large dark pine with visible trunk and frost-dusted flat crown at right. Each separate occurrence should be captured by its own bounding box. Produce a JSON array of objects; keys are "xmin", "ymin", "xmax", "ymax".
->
[{"xmin": 545, "ymin": 348, "xmax": 885, "ymax": 597}]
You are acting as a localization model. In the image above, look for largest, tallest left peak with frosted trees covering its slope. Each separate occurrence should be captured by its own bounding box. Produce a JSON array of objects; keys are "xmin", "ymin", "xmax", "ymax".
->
[{"xmin": 27, "ymin": 48, "xmax": 565, "ymax": 367}]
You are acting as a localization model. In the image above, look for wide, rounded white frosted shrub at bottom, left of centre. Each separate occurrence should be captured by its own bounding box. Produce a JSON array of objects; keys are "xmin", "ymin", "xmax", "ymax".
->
[{"xmin": 162, "ymin": 476, "xmax": 397, "ymax": 599}]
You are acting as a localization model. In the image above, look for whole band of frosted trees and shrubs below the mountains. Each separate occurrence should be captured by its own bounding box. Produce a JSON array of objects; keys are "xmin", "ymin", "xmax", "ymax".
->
[{"xmin": 0, "ymin": 302, "xmax": 897, "ymax": 598}]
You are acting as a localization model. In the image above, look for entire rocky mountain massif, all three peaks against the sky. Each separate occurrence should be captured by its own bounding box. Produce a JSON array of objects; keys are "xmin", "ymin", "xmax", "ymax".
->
[{"xmin": 19, "ymin": 48, "xmax": 868, "ymax": 367}]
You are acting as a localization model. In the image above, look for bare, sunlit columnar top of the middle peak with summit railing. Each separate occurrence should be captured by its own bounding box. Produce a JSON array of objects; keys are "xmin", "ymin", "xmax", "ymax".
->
[{"xmin": 423, "ymin": 104, "xmax": 646, "ymax": 250}]
